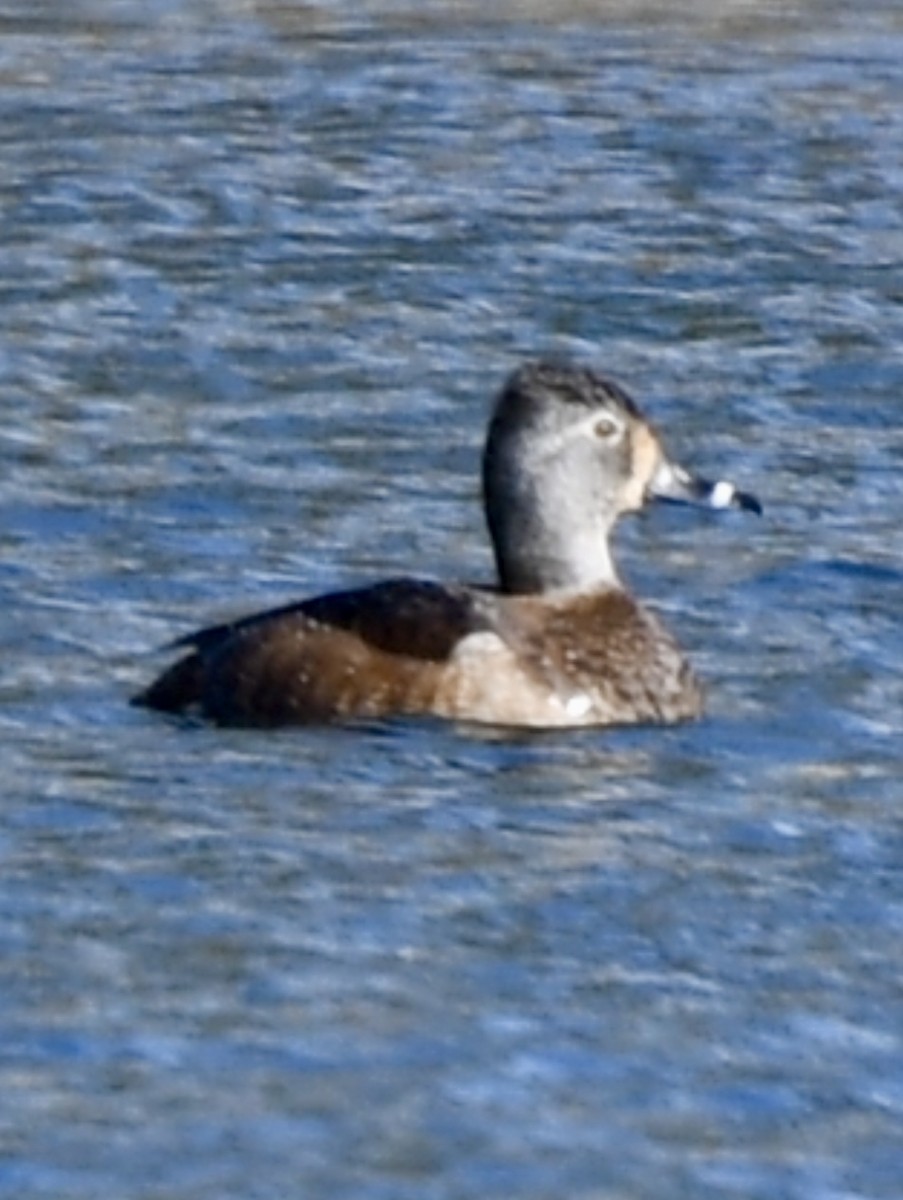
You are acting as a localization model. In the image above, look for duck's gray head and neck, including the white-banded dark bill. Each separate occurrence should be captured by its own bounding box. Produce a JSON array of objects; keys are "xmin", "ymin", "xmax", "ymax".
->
[{"xmin": 483, "ymin": 362, "xmax": 759, "ymax": 590}]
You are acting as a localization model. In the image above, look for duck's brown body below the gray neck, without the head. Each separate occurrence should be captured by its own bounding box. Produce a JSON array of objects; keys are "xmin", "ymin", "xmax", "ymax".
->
[{"xmin": 136, "ymin": 580, "xmax": 701, "ymax": 727}]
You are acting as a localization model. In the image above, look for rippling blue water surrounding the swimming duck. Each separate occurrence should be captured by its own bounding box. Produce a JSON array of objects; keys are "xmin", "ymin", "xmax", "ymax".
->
[{"xmin": 0, "ymin": 0, "xmax": 903, "ymax": 1200}]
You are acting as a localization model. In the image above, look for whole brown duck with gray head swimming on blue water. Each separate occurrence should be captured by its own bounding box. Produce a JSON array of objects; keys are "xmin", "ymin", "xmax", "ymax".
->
[{"xmin": 132, "ymin": 359, "xmax": 761, "ymax": 728}]
